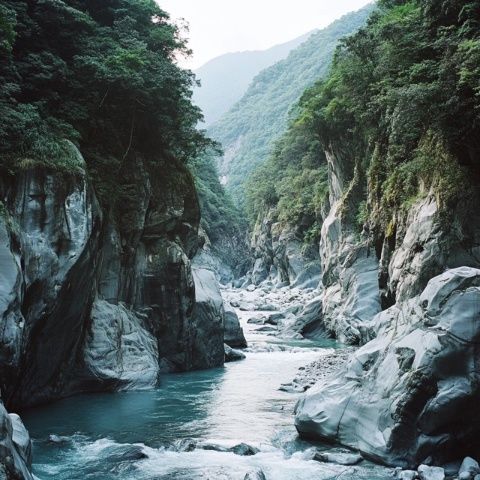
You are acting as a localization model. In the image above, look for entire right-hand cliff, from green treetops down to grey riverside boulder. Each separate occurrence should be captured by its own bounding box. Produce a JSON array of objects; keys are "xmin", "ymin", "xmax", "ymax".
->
[{"xmin": 247, "ymin": 0, "xmax": 480, "ymax": 467}]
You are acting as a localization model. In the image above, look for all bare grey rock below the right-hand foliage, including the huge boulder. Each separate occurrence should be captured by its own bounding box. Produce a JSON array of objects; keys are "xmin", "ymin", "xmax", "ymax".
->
[{"xmin": 296, "ymin": 141, "xmax": 480, "ymax": 467}]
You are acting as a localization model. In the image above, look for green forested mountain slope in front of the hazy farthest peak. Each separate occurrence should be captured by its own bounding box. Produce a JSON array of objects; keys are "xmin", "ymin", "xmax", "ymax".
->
[{"xmin": 209, "ymin": 5, "xmax": 374, "ymax": 201}]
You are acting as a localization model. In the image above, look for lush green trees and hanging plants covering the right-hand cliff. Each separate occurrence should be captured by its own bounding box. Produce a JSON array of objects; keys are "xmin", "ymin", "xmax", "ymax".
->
[{"xmin": 248, "ymin": 0, "xmax": 480, "ymax": 236}]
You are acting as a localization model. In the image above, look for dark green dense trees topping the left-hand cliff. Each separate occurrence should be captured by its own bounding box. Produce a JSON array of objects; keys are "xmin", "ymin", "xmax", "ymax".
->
[{"xmin": 0, "ymin": 0, "xmax": 208, "ymax": 204}]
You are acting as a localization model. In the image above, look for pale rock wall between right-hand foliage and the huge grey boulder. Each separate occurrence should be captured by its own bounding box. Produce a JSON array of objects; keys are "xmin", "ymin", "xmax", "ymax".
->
[{"xmin": 320, "ymin": 144, "xmax": 480, "ymax": 344}]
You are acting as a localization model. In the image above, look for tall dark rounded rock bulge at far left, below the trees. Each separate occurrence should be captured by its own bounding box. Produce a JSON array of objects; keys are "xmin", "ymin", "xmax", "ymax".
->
[{"xmin": 0, "ymin": 170, "xmax": 100, "ymax": 406}]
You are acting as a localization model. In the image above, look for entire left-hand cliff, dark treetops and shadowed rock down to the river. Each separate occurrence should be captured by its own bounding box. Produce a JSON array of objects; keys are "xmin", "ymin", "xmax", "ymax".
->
[{"xmin": 0, "ymin": 0, "xmax": 229, "ymax": 479}]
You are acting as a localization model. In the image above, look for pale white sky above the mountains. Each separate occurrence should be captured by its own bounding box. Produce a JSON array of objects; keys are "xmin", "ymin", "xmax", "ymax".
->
[{"xmin": 157, "ymin": 0, "xmax": 371, "ymax": 69}]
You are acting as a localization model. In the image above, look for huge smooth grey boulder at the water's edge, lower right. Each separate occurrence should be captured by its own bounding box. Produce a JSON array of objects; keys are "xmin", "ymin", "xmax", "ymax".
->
[{"xmin": 295, "ymin": 267, "xmax": 480, "ymax": 467}]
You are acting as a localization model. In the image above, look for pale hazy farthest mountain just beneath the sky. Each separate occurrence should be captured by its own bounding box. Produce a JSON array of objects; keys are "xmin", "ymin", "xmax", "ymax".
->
[{"xmin": 193, "ymin": 32, "xmax": 312, "ymax": 127}]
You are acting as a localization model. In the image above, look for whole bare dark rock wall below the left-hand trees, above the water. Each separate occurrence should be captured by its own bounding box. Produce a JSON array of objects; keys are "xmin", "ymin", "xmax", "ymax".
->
[{"xmin": 0, "ymin": 156, "xmax": 224, "ymax": 409}]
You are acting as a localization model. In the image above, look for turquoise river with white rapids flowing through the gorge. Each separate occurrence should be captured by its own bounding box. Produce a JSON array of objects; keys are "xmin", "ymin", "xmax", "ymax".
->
[{"xmin": 24, "ymin": 288, "xmax": 392, "ymax": 480}]
